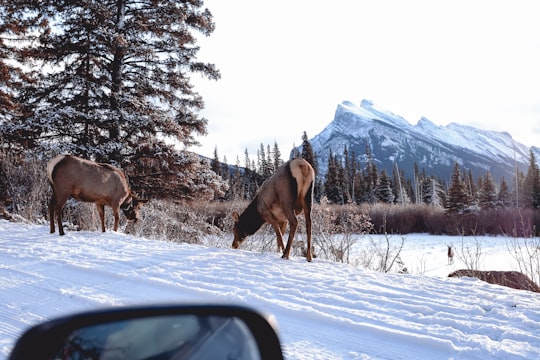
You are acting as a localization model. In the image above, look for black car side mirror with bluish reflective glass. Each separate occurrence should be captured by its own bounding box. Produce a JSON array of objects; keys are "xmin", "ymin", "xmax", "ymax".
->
[{"xmin": 9, "ymin": 305, "xmax": 283, "ymax": 360}]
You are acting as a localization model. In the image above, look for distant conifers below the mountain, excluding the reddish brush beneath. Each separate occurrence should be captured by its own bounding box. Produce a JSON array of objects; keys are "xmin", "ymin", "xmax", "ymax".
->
[{"xmin": 211, "ymin": 132, "xmax": 540, "ymax": 214}]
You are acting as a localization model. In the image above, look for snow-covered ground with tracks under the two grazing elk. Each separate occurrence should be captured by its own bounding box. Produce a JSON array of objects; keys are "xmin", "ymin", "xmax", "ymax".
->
[{"xmin": 0, "ymin": 220, "xmax": 540, "ymax": 360}]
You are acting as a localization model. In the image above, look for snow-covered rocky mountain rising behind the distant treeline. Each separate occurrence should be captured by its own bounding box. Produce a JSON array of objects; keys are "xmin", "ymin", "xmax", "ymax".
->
[{"xmin": 310, "ymin": 100, "xmax": 540, "ymax": 182}]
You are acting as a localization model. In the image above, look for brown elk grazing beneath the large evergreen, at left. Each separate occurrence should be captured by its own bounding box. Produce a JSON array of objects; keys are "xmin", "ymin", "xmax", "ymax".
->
[{"xmin": 47, "ymin": 155, "xmax": 146, "ymax": 235}]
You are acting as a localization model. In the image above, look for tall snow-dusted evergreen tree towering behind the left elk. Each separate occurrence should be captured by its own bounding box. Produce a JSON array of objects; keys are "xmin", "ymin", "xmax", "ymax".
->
[{"xmin": 2, "ymin": 0, "xmax": 220, "ymax": 198}]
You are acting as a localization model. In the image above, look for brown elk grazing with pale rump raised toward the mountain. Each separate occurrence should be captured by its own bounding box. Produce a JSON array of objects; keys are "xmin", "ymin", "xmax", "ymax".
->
[{"xmin": 232, "ymin": 159, "xmax": 315, "ymax": 261}]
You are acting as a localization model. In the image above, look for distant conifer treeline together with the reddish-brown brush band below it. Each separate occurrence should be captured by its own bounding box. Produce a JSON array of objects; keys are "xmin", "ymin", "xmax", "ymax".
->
[{"xmin": 211, "ymin": 133, "xmax": 540, "ymax": 236}]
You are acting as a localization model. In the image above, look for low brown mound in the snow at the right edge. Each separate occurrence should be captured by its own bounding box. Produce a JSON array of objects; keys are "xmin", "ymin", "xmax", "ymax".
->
[{"xmin": 448, "ymin": 270, "xmax": 540, "ymax": 292}]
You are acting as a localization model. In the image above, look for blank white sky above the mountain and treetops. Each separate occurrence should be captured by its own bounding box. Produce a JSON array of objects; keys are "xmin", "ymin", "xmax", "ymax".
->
[{"xmin": 192, "ymin": 0, "xmax": 540, "ymax": 165}]
